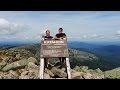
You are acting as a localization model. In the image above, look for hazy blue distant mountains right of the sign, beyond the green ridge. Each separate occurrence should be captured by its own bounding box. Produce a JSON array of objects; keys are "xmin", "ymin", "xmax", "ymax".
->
[{"xmin": 69, "ymin": 42, "xmax": 120, "ymax": 65}]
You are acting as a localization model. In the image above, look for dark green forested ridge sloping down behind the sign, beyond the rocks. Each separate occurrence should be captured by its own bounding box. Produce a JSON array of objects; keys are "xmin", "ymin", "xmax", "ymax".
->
[{"xmin": 0, "ymin": 44, "xmax": 116, "ymax": 70}]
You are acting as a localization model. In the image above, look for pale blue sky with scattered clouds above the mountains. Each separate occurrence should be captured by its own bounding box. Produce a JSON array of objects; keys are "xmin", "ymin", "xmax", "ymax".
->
[{"xmin": 0, "ymin": 11, "xmax": 120, "ymax": 42}]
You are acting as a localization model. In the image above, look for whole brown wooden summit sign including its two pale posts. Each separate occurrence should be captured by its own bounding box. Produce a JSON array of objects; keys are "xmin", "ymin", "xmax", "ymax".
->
[{"xmin": 40, "ymin": 40, "xmax": 71, "ymax": 79}]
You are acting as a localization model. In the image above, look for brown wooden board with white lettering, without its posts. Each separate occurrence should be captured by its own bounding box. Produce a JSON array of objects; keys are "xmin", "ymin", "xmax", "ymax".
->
[{"xmin": 40, "ymin": 40, "xmax": 69, "ymax": 58}]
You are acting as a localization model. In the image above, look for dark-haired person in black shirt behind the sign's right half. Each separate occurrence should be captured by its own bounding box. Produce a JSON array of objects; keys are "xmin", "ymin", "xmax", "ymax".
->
[{"xmin": 55, "ymin": 28, "xmax": 67, "ymax": 63}]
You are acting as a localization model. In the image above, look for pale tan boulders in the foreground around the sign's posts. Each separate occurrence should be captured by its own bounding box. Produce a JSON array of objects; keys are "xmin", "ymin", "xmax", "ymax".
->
[{"xmin": 0, "ymin": 57, "xmax": 104, "ymax": 79}]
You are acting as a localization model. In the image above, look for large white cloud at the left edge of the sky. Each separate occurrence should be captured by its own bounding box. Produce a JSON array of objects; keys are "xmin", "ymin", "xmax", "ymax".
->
[{"xmin": 0, "ymin": 18, "xmax": 29, "ymax": 35}]
